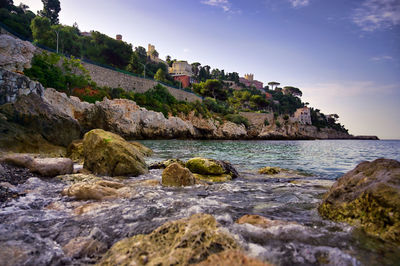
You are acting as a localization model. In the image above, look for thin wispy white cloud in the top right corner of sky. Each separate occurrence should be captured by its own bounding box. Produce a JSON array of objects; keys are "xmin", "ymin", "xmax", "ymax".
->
[{"xmin": 353, "ymin": 0, "xmax": 400, "ymax": 31}]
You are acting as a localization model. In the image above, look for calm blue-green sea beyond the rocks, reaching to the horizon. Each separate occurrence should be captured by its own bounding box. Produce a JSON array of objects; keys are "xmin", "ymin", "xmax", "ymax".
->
[{"xmin": 142, "ymin": 140, "xmax": 400, "ymax": 179}]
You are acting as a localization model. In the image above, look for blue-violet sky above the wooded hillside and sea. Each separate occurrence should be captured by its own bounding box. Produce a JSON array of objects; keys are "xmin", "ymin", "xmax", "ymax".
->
[{"xmin": 20, "ymin": 0, "xmax": 400, "ymax": 139}]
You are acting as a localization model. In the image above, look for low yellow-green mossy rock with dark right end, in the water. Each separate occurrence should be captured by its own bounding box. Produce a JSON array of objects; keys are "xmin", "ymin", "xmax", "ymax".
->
[{"xmin": 186, "ymin": 157, "xmax": 239, "ymax": 182}]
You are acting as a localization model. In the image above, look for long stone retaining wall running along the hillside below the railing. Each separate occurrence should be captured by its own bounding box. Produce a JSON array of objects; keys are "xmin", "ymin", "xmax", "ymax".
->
[{"xmin": 83, "ymin": 62, "xmax": 202, "ymax": 102}]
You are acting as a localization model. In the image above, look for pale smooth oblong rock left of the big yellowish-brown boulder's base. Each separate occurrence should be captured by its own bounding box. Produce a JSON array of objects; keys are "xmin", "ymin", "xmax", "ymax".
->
[{"xmin": 29, "ymin": 158, "xmax": 74, "ymax": 177}]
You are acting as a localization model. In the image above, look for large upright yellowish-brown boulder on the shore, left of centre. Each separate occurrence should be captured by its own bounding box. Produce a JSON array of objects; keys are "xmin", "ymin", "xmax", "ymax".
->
[{"xmin": 83, "ymin": 129, "xmax": 148, "ymax": 176}]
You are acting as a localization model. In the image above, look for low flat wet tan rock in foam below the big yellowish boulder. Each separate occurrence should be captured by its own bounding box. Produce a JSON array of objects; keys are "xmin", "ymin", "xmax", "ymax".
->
[{"xmin": 61, "ymin": 180, "xmax": 124, "ymax": 200}]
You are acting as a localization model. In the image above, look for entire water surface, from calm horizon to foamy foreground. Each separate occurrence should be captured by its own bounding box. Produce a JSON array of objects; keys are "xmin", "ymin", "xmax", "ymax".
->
[{"xmin": 0, "ymin": 140, "xmax": 400, "ymax": 266}]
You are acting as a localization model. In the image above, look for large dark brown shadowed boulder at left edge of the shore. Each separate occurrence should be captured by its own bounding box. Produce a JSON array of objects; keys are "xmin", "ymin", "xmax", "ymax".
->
[{"xmin": 0, "ymin": 94, "xmax": 81, "ymax": 147}]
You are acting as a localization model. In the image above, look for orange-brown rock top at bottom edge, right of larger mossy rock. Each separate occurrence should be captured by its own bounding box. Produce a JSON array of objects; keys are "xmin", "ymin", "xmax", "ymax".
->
[{"xmin": 196, "ymin": 250, "xmax": 271, "ymax": 266}]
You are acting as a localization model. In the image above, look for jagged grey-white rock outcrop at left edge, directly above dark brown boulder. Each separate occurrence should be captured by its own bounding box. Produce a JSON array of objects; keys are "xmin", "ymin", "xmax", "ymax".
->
[{"xmin": 0, "ymin": 68, "xmax": 44, "ymax": 105}]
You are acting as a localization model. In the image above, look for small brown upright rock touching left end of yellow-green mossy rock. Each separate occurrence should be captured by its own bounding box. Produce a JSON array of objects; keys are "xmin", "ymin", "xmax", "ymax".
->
[{"xmin": 161, "ymin": 163, "xmax": 195, "ymax": 187}]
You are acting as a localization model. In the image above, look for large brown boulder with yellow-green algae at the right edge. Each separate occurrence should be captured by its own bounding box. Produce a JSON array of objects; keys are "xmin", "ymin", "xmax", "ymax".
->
[{"xmin": 318, "ymin": 159, "xmax": 400, "ymax": 243}]
